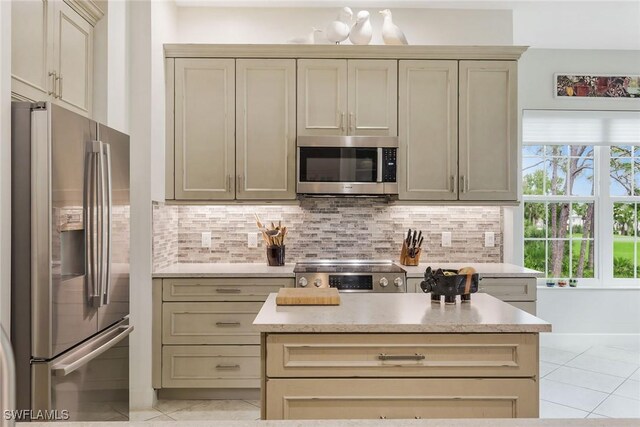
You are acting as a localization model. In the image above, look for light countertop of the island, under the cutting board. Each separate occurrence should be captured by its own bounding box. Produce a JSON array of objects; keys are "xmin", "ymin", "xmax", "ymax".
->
[{"xmin": 253, "ymin": 293, "xmax": 551, "ymax": 333}]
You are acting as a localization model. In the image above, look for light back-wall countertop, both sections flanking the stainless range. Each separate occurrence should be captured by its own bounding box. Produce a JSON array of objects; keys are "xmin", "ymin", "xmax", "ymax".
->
[{"xmin": 153, "ymin": 262, "xmax": 542, "ymax": 278}]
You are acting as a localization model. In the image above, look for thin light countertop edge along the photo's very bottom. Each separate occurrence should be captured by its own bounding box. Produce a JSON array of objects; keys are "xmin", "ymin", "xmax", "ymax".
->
[{"xmin": 17, "ymin": 418, "xmax": 638, "ymax": 427}]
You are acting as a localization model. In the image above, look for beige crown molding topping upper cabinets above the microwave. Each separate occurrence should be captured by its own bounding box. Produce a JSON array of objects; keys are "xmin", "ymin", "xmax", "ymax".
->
[{"xmin": 164, "ymin": 44, "xmax": 528, "ymax": 61}]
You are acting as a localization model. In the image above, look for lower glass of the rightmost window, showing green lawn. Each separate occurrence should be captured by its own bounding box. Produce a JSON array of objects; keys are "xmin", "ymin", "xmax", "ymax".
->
[{"xmin": 613, "ymin": 203, "xmax": 637, "ymax": 278}]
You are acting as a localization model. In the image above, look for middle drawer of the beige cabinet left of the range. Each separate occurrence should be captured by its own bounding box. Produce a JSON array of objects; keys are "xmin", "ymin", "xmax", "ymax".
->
[{"xmin": 162, "ymin": 302, "xmax": 262, "ymax": 345}]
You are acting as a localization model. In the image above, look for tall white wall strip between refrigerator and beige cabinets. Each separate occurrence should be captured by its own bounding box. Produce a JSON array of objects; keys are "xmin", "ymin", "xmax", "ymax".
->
[{"xmin": 127, "ymin": 0, "xmax": 175, "ymax": 414}]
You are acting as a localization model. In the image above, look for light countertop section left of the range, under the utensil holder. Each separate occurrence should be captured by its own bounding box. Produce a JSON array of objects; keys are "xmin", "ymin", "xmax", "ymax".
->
[{"xmin": 153, "ymin": 262, "xmax": 295, "ymax": 278}]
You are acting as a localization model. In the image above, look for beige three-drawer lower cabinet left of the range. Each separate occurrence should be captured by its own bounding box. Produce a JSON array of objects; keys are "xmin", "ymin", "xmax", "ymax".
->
[{"xmin": 152, "ymin": 277, "xmax": 294, "ymax": 397}]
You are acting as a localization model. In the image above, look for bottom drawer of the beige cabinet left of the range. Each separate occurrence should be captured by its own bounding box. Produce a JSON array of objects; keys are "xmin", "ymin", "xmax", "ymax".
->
[{"xmin": 162, "ymin": 345, "xmax": 260, "ymax": 388}]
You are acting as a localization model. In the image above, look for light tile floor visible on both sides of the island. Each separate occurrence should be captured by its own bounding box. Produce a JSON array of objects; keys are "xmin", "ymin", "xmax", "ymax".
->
[{"xmin": 132, "ymin": 345, "xmax": 640, "ymax": 421}]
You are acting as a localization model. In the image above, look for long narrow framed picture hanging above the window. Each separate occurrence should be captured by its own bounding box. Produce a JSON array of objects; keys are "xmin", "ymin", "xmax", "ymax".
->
[{"xmin": 554, "ymin": 73, "xmax": 640, "ymax": 99}]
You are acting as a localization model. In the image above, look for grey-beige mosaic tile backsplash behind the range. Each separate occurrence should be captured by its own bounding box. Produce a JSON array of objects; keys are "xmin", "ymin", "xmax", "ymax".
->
[{"xmin": 153, "ymin": 198, "xmax": 503, "ymax": 269}]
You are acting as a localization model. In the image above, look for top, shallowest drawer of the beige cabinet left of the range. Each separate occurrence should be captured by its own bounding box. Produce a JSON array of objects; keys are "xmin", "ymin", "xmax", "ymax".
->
[{"xmin": 162, "ymin": 277, "xmax": 294, "ymax": 302}]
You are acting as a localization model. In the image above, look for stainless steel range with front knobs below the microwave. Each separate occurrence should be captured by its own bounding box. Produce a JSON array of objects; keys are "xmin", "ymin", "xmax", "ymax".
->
[{"xmin": 293, "ymin": 260, "xmax": 407, "ymax": 292}]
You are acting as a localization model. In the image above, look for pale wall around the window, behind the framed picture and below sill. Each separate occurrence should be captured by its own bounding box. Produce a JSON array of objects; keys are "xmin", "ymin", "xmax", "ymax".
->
[{"xmin": 516, "ymin": 49, "xmax": 640, "ymax": 343}]
